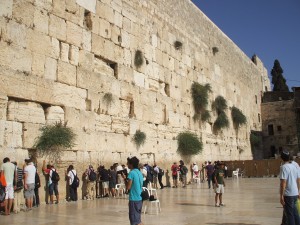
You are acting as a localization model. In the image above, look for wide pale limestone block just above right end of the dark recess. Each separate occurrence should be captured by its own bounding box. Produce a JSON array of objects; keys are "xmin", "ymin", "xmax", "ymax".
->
[{"xmin": 53, "ymin": 83, "xmax": 87, "ymax": 110}]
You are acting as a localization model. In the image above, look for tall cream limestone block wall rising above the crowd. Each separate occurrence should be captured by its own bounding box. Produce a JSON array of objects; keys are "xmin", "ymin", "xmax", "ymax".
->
[{"xmin": 0, "ymin": 0, "xmax": 269, "ymax": 170}]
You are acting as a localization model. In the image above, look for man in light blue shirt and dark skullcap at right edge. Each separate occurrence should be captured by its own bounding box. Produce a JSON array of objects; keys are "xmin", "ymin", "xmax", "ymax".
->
[{"xmin": 279, "ymin": 151, "xmax": 300, "ymax": 225}]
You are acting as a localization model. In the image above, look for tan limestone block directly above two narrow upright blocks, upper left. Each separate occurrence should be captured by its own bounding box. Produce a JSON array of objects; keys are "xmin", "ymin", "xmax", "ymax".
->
[{"xmin": 49, "ymin": 14, "xmax": 67, "ymax": 41}]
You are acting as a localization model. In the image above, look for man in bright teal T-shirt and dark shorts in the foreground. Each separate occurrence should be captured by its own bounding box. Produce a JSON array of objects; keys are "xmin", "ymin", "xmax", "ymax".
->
[{"xmin": 122, "ymin": 157, "xmax": 143, "ymax": 225}]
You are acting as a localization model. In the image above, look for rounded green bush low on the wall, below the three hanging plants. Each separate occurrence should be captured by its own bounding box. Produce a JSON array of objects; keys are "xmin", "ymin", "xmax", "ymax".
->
[{"xmin": 177, "ymin": 131, "xmax": 203, "ymax": 156}]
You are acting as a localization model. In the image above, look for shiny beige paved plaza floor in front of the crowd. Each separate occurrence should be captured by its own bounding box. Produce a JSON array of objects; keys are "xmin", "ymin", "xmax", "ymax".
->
[{"xmin": 0, "ymin": 178, "xmax": 282, "ymax": 225}]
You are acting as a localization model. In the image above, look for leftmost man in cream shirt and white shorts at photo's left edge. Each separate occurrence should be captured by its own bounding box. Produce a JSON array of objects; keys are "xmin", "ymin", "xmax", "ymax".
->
[{"xmin": 0, "ymin": 158, "xmax": 17, "ymax": 216}]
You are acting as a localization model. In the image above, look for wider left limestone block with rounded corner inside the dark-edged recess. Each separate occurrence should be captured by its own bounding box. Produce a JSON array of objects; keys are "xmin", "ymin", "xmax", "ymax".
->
[{"xmin": 7, "ymin": 101, "xmax": 45, "ymax": 124}]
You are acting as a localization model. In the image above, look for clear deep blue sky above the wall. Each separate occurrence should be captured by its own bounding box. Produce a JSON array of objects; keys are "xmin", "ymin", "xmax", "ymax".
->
[{"xmin": 192, "ymin": 0, "xmax": 300, "ymax": 87}]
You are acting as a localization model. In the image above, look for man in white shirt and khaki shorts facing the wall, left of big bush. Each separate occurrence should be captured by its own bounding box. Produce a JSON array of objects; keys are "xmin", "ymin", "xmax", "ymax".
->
[{"xmin": 24, "ymin": 159, "xmax": 36, "ymax": 211}]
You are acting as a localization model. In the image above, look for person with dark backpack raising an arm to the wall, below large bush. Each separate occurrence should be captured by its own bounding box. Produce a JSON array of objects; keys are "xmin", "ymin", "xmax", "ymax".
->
[{"xmin": 43, "ymin": 160, "xmax": 60, "ymax": 204}]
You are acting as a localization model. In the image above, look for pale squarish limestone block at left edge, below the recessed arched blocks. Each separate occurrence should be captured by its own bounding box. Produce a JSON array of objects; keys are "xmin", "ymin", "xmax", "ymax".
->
[{"xmin": 0, "ymin": 120, "xmax": 22, "ymax": 148}]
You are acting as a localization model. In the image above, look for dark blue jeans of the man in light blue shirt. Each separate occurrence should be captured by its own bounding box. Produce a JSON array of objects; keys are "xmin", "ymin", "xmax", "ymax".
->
[{"xmin": 284, "ymin": 196, "xmax": 300, "ymax": 225}]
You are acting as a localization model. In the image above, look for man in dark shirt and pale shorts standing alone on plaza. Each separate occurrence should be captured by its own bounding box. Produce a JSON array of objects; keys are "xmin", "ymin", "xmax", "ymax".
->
[{"xmin": 214, "ymin": 162, "xmax": 225, "ymax": 207}]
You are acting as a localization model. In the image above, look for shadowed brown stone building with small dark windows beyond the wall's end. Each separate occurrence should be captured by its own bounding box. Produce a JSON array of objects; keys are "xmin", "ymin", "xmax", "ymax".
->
[{"xmin": 262, "ymin": 88, "xmax": 300, "ymax": 158}]
